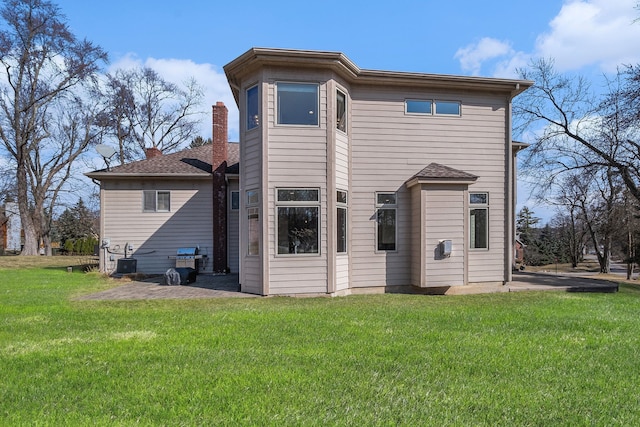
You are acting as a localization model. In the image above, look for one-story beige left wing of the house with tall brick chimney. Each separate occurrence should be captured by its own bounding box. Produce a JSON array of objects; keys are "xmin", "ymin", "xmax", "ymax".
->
[{"xmin": 87, "ymin": 103, "xmax": 239, "ymax": 273}]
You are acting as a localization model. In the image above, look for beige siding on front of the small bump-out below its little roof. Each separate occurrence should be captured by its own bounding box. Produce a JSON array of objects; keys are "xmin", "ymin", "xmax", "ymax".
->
[{"xmin": 423, "ymin": 185, "xmax": 467, "ymax": 286}]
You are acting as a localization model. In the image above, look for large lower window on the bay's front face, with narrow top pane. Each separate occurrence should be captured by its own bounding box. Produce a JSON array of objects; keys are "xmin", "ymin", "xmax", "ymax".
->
[{"xmin": 276, "ymin": 188, "xmax": 320, "ymax": 255}]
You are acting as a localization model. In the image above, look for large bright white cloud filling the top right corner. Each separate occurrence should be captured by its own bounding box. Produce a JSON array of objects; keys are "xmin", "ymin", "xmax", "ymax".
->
[{"xmin": 535, "ymin": 0, "xmax": 640, "ymax": 72}]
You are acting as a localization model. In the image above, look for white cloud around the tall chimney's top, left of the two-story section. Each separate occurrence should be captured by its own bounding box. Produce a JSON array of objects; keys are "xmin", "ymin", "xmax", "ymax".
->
[{"xmin": 109, "ymin": 54, "xmax": 239, "ymax": 141}]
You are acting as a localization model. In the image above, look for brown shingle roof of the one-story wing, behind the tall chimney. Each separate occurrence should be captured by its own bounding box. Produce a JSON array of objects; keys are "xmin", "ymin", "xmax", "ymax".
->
[{"xmin": 87, "ymin": 142, "xmax": 240, "ymax": 178}]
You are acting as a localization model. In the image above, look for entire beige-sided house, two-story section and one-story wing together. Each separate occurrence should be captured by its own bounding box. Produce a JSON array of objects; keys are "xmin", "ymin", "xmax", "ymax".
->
[{"xmin": 88, "ymin": 48, "xmax": 532, "ymax": 295}]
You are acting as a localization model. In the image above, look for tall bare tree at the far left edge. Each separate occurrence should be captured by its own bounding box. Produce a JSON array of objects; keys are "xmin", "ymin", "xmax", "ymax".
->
[{"xmin": 0, "ymin": 0, "xmax": 107, "ymax": 255}]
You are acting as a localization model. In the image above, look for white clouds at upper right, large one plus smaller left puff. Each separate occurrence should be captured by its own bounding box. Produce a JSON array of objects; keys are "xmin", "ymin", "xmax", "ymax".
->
[{"xmin": 455, "ymin": 0, "xmax": 640, "ymax": 77}]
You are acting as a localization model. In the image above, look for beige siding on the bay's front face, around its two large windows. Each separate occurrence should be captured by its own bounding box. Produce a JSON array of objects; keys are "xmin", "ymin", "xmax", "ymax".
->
[{"xmin": 265, "ymin": 76, "xmax": 333, "ymax": 295}]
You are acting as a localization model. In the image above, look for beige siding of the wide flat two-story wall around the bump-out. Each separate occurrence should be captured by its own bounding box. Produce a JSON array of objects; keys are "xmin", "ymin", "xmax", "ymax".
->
[{"xmin": 350, "ymin": 86, "xmax": 507, "ymax": 287}]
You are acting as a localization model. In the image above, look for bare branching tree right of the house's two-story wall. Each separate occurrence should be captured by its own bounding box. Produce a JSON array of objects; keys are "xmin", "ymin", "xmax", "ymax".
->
[{"xmin": 514, "ymin": 60, "xmax": 640, "ymax": 206}]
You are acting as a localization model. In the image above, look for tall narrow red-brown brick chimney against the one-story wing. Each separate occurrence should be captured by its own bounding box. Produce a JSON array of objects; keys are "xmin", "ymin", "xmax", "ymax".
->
[{"xmin": 211, "ymin": 101, "xmax": 229, "ymax": 273}]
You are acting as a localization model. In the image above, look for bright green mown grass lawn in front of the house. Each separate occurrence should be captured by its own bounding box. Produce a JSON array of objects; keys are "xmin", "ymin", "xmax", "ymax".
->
[{"xmin": 0, "ymin": 261, "xmax": 640, "ymax": 426}]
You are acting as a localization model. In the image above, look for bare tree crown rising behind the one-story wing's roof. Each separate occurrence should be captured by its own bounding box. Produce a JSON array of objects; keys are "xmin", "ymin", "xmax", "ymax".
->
[{"xmin": 108, "ymin": 67, "xmax": 203, "ymax": 162}]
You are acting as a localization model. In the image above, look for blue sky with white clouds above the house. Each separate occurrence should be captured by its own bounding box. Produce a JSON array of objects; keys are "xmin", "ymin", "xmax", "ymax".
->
[{"xmin": 52, "ymin": 0, "xmax": 640, "ymax": 219}]
